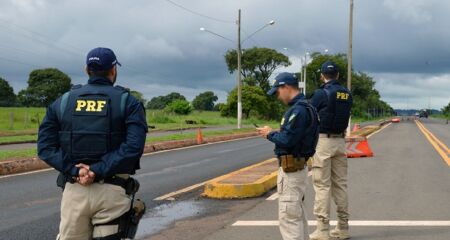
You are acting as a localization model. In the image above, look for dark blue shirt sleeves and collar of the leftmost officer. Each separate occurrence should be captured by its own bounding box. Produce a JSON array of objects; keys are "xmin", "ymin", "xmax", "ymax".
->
[{"xmin": 37, "ymin": 77, "xmax": 148, "ymax": 179}]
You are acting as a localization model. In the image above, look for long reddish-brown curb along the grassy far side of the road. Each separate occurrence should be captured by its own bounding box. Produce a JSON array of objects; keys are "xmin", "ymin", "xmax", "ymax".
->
[{"xmin": 0, "ymin": 133, "xmax": 257, "ymax": 176}]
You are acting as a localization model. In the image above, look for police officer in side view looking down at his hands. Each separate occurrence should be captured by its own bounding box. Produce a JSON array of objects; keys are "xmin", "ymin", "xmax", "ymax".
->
[{"xmin": 257, "ymin": 73, "xmax": 319, "ymax": 240}]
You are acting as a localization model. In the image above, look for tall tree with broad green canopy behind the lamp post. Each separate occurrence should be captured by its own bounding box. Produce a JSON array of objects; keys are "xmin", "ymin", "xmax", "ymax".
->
[{"xmin": 225, "ymin": 47, "xmax": 291, "ymax": 92}]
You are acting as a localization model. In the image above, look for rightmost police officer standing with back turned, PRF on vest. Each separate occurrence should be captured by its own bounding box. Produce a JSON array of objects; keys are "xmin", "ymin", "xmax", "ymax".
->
[{"xmin": 310, "ymin": 61, "xmax": 352, "ymax": 240}]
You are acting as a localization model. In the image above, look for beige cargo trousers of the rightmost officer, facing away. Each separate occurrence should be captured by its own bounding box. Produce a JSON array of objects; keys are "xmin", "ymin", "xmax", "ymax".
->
[{"xmin": 312, "ymin": 136, "xmax": 349, "ymax": 224}]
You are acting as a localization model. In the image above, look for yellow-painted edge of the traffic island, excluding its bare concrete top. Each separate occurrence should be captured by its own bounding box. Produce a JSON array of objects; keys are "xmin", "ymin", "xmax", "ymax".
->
[{"xmin": 203, "ymin": 158, "xmax": 278, "ymax": 199}]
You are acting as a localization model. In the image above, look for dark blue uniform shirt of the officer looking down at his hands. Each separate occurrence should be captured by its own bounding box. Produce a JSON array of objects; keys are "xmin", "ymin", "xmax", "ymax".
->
[{"xmin": 267, "ymin": 94, "xmax": 311, "ymax": 156}]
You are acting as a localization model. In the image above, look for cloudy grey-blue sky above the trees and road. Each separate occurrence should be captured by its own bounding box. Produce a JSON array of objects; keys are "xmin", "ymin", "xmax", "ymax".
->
[{"xmin": 0, "ymin": 0, "xmax": 450, "ymax": 108}]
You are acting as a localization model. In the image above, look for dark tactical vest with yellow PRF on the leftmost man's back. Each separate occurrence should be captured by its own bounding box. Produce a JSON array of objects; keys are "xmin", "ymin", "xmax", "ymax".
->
[{"xmin": 58, "ymin": 84, "xmax": 129, "ymax": 164}]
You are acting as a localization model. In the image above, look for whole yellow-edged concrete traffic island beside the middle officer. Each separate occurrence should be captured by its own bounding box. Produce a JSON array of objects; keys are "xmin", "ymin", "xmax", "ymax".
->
[{"xmin": 203, "ymin": 158, "xmax": 278, "ymax": 199}]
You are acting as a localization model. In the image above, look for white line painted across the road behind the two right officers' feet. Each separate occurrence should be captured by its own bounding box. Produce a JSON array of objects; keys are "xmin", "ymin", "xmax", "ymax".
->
[{"xmin": 232, "ymin": 221, "xmax": 450, "ymax": 227}]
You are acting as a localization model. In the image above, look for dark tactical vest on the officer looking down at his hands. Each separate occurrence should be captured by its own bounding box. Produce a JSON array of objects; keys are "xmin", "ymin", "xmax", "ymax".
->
[{"xmin": 294, "ymin": 99, "xmax": 319, "ymax": 158}]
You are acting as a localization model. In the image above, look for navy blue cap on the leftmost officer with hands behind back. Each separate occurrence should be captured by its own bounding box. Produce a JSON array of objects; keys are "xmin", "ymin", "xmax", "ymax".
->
[{"xmin": 86, "ymin": 47, "xmax": 122, "ymax": 71}]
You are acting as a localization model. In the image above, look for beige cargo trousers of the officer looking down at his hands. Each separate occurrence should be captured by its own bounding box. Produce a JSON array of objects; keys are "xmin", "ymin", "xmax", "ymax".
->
[{"xmin": 277, "ymin": 167, "xmax": 309, "ymax": 240}]
